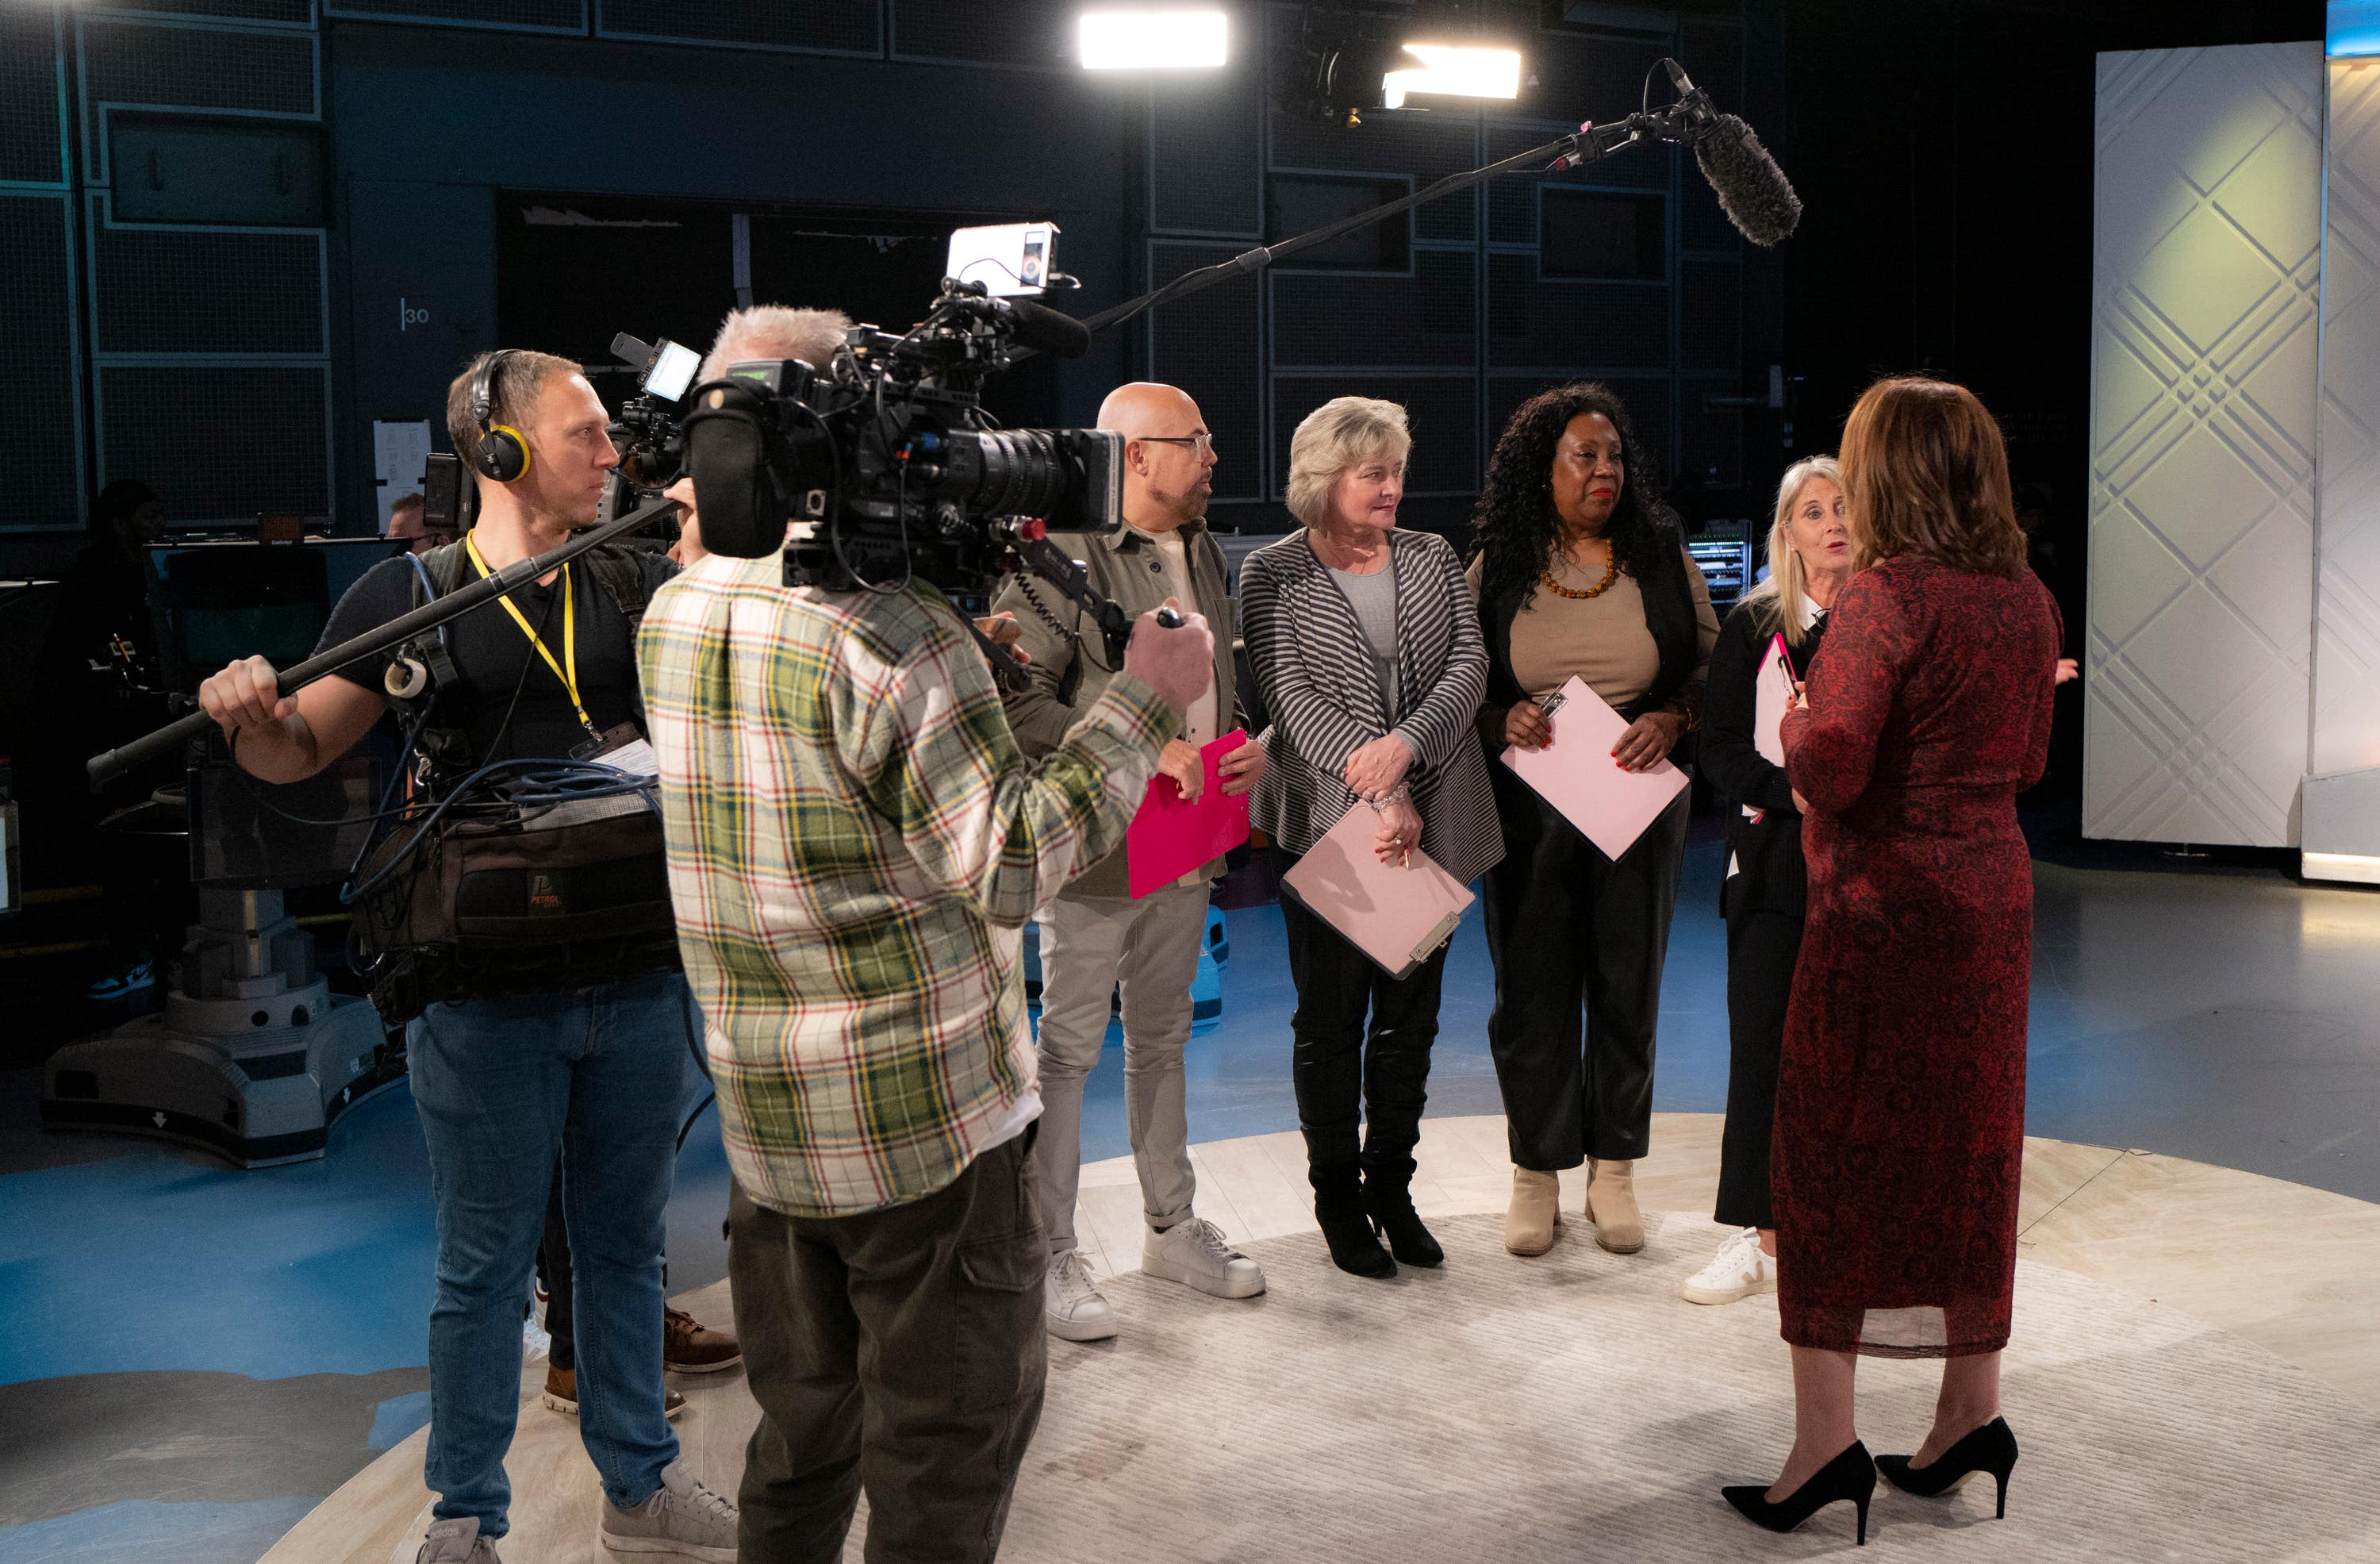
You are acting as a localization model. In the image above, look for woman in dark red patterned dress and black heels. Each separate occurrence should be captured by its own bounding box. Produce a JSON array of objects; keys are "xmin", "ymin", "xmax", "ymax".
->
[{"xmin": 1726, "ymin": 379, "xmax": 2061, "ymax": 1540}]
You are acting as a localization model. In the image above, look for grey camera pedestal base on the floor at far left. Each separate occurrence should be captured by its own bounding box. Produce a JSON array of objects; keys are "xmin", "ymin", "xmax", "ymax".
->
[{"xmin": 40, "ymin": 890, "xmax": 405, "ymax": 1166}]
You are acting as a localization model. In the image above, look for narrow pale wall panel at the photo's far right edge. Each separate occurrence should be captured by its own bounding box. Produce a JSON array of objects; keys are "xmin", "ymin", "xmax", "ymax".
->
[{"xmin": 2311, "ymin": 60, "xmax": 2380, "ymax": 776}]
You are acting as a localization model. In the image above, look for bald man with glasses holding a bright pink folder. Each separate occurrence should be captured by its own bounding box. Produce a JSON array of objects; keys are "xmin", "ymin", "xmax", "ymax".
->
[{"xmin": 997, "ymin": 381, "xmax": 1264, "ymax": 1340}]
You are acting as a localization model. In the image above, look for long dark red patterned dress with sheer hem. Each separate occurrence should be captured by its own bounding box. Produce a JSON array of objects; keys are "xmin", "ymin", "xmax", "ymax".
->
[{"xmin": 1773, "ymin": 555, "xmax": 2061, "ymax": 1357}]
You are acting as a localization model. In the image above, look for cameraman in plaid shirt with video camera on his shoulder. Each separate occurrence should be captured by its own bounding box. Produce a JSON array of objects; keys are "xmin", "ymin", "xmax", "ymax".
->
[{"xmin": 640, "ymin": 486, "xmax": 1214, "ymax": 1564}]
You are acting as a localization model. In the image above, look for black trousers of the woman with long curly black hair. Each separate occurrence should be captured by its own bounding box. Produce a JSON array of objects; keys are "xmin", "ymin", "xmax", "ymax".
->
[{"xmin": 1483, "ymin": 767, "xmax": 1690, "ymax": 1174}]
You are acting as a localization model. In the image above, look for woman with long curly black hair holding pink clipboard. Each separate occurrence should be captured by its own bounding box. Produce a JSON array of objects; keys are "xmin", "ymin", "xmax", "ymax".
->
[{"xmin": 1471, "ymin": 381, "xmax": 1718, "ymax": 1255}]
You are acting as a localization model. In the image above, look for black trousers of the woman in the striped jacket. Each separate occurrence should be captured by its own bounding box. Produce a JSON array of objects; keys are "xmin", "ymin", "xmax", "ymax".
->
[{"xmin": 1280, "ymin": 864, "xmax": 1447, "ymax": 1190}]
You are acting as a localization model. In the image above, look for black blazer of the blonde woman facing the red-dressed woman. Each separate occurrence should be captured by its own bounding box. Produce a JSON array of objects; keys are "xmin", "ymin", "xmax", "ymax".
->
[{"xmin": 1702, "ymin": 602, "xmax": 1825, "ymax": 921}]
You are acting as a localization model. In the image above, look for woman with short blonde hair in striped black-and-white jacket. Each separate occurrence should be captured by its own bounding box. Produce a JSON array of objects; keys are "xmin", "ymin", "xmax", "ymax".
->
[{"xmin": 1240, "ymin": 398, "xmax": 1504, "ymax": 1276}]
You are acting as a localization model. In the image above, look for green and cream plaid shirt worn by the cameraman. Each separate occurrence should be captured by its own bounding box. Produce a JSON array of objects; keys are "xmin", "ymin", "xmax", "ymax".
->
[{"xmin": 638, "ymin": 557, "xmax": 1176, "ymax": 1216}]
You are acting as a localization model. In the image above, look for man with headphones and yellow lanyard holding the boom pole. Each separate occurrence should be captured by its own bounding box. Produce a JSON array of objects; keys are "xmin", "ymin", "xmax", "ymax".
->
[{"xmin": 200, "ymin": 350, "xmax": 735, "ymax": 1564}]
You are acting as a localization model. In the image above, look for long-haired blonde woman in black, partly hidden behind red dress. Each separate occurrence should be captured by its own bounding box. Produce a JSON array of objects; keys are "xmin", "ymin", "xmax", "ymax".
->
[{"xmin": 1678, "ymin": 457, "xmax": 1852, "ymax": 1305}]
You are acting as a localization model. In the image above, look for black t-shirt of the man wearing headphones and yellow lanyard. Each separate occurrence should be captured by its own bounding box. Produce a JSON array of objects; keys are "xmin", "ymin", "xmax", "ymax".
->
[{"xmin": 314, "ymin": 552, "xmax": 678, "ymax": 764}]
